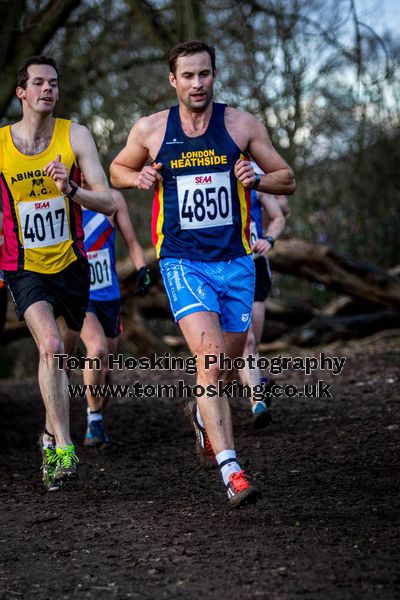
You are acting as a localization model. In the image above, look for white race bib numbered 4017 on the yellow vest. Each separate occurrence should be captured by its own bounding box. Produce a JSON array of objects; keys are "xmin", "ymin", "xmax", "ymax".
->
[{"xmin": 17, "ymin": 196, "xmax": 69, "ymax": 248}]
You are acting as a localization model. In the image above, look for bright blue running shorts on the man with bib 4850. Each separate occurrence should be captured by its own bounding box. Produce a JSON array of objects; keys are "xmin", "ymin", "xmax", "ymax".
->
[{"xmin": 160, "ymin": 255, "xmax": 255, "ymax": 333}]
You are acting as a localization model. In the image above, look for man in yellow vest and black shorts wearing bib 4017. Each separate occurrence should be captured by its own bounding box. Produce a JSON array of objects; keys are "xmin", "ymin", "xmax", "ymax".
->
[{"xmin": 0, "ymin": 56, "xmax": 114, "ymax": 491}]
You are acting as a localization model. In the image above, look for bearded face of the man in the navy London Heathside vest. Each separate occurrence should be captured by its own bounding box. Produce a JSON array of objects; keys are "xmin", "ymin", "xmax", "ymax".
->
[{"xmin": 169, "ymin": 52, "xmax": 214, "ymax": 112}]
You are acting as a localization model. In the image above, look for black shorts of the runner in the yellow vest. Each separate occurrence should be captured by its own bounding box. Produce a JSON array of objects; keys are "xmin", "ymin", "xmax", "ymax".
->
[{"xmin": 4, "ymin": 258, "xmax": 90, "ymax": 331}]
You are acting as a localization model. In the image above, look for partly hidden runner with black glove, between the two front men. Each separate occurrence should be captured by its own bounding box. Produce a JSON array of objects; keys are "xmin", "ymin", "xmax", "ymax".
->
[{"xmin": 81, "ymin": 178, "xmax": 150, "ymax": 447}]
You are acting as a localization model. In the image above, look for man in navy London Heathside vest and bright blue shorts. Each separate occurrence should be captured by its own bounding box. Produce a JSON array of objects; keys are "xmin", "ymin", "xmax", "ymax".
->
[{"xmin": 111, "ymin": 41, "xmax": 295, "ymax": 506}]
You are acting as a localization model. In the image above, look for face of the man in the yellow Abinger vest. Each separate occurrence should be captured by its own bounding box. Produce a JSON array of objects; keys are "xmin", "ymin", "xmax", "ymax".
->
[{"xmin": 16, "ymin": 65, "xmax": 58, "ymax": 114}]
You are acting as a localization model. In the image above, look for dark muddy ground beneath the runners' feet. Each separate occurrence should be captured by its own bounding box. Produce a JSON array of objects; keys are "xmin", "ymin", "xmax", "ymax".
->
[{"xmin": 0, "ymin": 339, "xmax": 400, "ymax": 600}]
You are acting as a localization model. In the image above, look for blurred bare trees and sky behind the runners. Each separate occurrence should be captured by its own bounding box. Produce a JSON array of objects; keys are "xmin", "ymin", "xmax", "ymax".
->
[{"xmin": 0, "ymin": 0, "xmax": 400, "ymax": 308}]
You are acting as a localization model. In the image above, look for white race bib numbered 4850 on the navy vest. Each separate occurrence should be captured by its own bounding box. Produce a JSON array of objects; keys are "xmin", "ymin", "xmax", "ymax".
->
[{"xmin": 176, "ymin": 171, "xmax": 233, "ymax": 229}]
